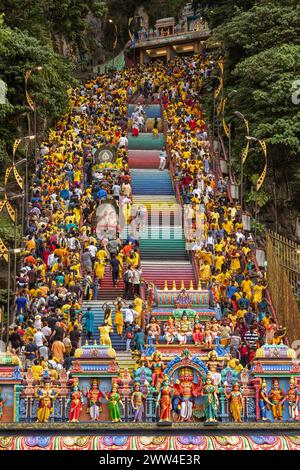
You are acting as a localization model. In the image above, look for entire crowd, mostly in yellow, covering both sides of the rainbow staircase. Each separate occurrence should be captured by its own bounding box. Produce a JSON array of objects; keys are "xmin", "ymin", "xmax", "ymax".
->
[{"xmin": 1, "ymin": 56, "xmax": 286, "ymax": 382}]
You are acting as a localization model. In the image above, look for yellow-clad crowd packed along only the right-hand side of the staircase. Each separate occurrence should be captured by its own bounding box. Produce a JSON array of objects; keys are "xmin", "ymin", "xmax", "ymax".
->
[{"xmin": 161, "ymin": 54, "xmax": 286, "ymax": 365}]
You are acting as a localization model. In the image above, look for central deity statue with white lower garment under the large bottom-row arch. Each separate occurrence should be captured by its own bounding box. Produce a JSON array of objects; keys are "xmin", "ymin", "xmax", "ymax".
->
[{"xmin": 173, "ymin": 367, "xmax": 201, "ymax": 421}]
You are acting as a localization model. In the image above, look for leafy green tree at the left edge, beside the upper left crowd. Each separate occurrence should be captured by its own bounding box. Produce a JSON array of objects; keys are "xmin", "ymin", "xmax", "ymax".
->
[{"xmin": 0, "ymin": 18, "xmax": 76, "ymax": 159}]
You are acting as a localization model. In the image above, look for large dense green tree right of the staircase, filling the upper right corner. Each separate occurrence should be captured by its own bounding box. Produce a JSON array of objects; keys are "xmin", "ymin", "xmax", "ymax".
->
[{"xmin": 205, "ymin": 0, "xmax": 300, "ymax": 233}]
